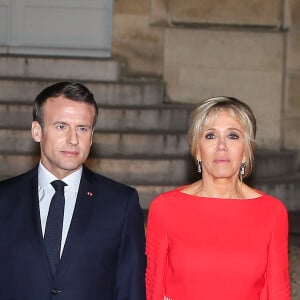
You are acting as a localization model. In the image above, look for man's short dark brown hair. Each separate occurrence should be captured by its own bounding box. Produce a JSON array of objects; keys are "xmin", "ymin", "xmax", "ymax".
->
[{"xmin": 32, "ymin": 81, "xmax": 98, "ymax": 127}]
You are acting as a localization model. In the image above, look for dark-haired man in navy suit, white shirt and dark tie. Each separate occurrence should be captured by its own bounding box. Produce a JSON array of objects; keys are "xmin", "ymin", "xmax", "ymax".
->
[{"xmin": 0, "ymin": 82, "xmax": 145, "ymax": 300}]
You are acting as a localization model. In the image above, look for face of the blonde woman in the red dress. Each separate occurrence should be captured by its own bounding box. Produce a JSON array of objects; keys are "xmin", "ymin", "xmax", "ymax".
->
[{"xmin": 197, "ymin": 110, "xmax": 246, "ymax": 179}]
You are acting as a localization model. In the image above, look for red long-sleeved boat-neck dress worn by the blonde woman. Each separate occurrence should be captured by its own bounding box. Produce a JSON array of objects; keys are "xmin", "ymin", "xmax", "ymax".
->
[{"xmin": 146, "ymin": 187, "xmax": 290, "ymax": 300}]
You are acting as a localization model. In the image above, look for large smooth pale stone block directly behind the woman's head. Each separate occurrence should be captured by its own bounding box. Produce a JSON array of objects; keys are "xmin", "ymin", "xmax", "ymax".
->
[{"xmin": 164, "ymin": 28, "xmax": 283, "ymax": 149}]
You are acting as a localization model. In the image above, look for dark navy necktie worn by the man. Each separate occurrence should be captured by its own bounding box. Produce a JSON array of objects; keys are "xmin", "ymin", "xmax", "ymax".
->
[{"xmin": 44, "ymin": 180, "xmax": 66, "ymax": 275}]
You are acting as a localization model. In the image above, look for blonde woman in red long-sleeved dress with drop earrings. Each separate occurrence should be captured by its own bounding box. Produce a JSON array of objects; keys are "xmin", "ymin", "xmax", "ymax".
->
[{"xmin": 146, "ymin": 97, "xmax": 290, "ymax": 300}]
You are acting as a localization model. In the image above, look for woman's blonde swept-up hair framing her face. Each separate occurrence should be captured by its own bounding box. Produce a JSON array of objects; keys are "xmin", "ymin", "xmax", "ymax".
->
[{"xmin": 188, "ymin": 96, "xmax": 256, "ymax": 178}]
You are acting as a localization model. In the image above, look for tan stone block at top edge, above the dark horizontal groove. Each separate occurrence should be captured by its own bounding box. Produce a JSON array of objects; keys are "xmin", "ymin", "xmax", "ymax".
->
[{"xmin": 169, "ymin": 0, "xmax": 282, "ymax": 27}]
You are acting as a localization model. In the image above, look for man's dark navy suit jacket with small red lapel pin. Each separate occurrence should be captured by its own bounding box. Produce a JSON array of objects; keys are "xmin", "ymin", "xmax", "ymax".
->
[{"xmin": 0, "ymin": 167, "xmax": 145, "ymax": 300}]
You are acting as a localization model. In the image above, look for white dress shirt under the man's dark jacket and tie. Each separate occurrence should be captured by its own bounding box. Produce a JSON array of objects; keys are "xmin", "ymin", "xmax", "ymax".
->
[{"xmin": 38, "ymin": 162, "xmax": 82, "ymax": 255}]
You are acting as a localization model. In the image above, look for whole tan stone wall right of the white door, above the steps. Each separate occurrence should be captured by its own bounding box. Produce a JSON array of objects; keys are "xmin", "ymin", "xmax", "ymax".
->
[{"xmin": 113, "ymin": 0, "xmax": 300, "ymax": 151}]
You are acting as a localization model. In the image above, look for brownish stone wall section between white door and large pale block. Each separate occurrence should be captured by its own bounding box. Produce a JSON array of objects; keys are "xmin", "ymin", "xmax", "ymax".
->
[{"xmin": 112, "ymin": 0, "xmax": 164, "ymax": 76}]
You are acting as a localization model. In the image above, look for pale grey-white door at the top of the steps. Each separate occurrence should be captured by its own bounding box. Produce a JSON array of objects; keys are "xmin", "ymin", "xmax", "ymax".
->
[{"xmin": 0, "ymin": 0, "xmax": 113, "ymax": 57}]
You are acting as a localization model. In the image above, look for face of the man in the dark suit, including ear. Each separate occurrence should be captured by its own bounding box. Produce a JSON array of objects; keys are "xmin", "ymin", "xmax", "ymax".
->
[{"xmin": 31, "ymin": 96, "xmax": 95, "ymax": 179}]
